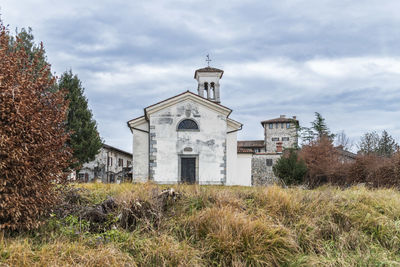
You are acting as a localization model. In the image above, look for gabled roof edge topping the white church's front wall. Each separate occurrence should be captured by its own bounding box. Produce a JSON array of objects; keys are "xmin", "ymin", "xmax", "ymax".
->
[{"xmin": 144, "ymin": 90, "xmax": 232, "ymax": 119}]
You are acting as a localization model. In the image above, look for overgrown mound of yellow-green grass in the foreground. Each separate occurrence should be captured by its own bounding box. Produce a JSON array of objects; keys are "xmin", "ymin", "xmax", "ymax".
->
[{"xmin": 0, "ymin": 183, "xmax": 400, "ymax": 266}]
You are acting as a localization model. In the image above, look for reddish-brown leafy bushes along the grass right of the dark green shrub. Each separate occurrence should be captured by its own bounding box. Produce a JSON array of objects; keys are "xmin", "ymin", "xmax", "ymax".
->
[{"xmin": 300, "ymin": 138, "xmax": 400, "ymax": 188}]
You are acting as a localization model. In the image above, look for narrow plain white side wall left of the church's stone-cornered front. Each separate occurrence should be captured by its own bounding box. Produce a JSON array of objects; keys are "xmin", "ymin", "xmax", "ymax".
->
[{"xmin": 132, "ymin": 121, "xmax": 149, "ymax": 182}]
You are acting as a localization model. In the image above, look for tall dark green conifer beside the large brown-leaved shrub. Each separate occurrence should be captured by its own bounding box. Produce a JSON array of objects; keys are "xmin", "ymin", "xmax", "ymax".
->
[{"xmin": 58, "ymin": 70, "xmax": 102, "ymax": 169}]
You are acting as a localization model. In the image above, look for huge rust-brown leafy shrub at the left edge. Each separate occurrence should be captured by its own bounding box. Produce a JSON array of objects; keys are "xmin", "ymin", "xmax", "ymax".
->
[{"xmin": 0, "ymin": 21, "xmax": 70, "ymax": 230}]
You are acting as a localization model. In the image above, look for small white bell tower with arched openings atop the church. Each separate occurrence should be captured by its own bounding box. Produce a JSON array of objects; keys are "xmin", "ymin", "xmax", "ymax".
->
[{"xmin": 194, "ymin": 67, "xmax": 224, "ymax": 103}]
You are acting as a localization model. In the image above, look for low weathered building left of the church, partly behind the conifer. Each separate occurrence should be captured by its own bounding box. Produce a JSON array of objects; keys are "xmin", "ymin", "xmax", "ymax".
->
[{"xmin": 77, "ymin": 144, "xmax": 132, "ymax": 183}]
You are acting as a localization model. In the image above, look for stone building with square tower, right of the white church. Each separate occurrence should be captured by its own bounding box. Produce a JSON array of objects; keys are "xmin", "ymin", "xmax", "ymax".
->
[{"xmin": 238, "ymin": 115, "xmax": 299, "ymax": 185}]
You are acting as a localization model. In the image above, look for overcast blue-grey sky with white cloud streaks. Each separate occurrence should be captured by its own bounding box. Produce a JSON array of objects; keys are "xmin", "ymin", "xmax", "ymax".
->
[{"xmin": 0, "ymin": 0, "xmax": 400, "ymax": 151}]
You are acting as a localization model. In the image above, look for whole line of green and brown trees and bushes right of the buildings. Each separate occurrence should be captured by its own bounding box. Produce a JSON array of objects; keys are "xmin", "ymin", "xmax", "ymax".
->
[{"xmin": 273, "ymin": 112, "xmax": 400, "ymax": 187}]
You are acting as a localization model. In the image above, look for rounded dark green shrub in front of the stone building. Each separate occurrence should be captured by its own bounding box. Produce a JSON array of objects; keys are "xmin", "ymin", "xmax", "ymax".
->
[{"xmin": 273, "ymin": 149, "xmax": 307, "ymax": 185}]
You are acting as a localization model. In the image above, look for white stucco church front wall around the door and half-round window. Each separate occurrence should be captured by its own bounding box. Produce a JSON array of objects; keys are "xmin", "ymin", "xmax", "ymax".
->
[{"xmin": 150, "ymin": 99, "xmax": 227, "ymax": 184}]
